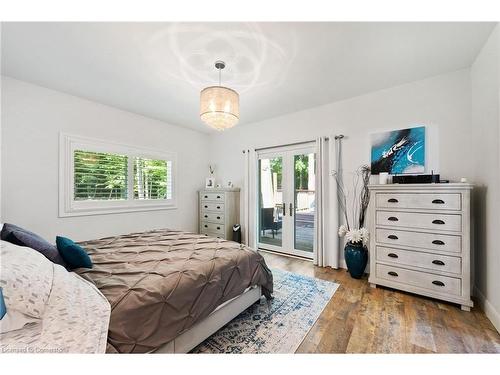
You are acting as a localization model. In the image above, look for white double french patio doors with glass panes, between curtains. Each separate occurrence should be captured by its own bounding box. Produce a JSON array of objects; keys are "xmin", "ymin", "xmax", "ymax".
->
[{"xmin": 257, "ymin": 143, "xmax": 316, "ymax": 258}]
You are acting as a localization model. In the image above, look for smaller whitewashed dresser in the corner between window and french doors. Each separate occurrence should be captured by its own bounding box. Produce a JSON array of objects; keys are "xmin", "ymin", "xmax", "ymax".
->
[{"xmin": 199, "ymin": 188, "xmax": 240, "ymax": 240}]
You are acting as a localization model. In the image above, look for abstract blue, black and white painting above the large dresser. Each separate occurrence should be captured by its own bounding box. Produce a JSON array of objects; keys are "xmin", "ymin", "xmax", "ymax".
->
[{"xmin": 371, "ymin": 126, "xmax": 425, "ymax": 174}]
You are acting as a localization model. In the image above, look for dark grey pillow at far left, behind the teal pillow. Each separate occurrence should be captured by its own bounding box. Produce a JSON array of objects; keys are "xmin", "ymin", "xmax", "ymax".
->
[{"xmin": 0, "ymin": 223, "xmax": 67, "ymax": 268}]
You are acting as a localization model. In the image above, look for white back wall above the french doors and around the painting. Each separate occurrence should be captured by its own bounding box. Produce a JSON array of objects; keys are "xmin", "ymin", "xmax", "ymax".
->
[{"xmin": 210, "ymin": 69, "xmax": 473, "ymax": 223}]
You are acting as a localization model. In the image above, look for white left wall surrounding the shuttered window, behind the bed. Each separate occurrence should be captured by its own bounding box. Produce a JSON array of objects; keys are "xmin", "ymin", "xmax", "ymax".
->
[{"xmin": 1, "ymin": 77, "xmax": 208, "ymax": 241}]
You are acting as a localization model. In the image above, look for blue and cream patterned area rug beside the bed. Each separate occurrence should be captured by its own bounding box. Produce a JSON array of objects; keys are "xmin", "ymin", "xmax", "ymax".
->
[{"xmin": 191, "ymin": 269, "xmax": 339, "ymax": 353}]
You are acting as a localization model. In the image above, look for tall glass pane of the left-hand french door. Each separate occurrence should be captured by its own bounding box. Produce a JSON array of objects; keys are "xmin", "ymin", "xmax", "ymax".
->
[{"xmin": 259, "ymin": 157, "xmax": 283, "ymax": 247}]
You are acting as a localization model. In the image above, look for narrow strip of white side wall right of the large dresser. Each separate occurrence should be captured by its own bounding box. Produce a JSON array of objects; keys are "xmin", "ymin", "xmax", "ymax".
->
[{"xmin": 469, "ymin": 26, "xmax": 500, "ymax": 330}]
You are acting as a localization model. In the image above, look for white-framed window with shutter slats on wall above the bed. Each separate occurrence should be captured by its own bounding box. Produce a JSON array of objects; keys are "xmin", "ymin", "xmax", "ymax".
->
[{"xmin": 59, "ymin": 134, "xmax": 176, "ymax": 216}]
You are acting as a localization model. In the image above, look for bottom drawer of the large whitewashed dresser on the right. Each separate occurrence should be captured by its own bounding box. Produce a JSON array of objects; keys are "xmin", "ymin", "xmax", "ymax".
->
[{"xmin": 376, "ymin": 264, "xmax": 462, "ymax": 296}]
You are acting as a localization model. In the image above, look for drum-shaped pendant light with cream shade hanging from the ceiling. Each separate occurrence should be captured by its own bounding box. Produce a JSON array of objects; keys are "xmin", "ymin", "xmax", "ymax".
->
[{"xmin": 200, "ymin": 61, "xmax": 240, "ymax": 130}]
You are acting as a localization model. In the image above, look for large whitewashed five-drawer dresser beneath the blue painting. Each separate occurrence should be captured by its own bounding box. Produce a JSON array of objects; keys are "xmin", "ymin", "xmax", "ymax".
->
[{"xmin": 369, "ymin": 183, "xmax": 473, "ymax": 311}]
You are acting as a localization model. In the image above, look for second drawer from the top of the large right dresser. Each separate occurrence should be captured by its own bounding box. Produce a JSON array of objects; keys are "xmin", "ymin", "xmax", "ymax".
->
[{"xmin": 376, "ymin": 211, "xmax": 462, "ymax": 232}]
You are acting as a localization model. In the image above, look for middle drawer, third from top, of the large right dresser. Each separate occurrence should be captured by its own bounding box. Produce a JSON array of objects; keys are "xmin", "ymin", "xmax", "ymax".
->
[{"xmin": 375, "ymin": 228, "xmax": 462, "ymax": 254}]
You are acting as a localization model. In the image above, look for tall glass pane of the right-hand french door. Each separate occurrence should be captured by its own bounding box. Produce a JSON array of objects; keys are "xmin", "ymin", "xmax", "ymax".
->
[{"xmin": 294, "ymin": 154, "xmax": 316, "ymax": 253}]
